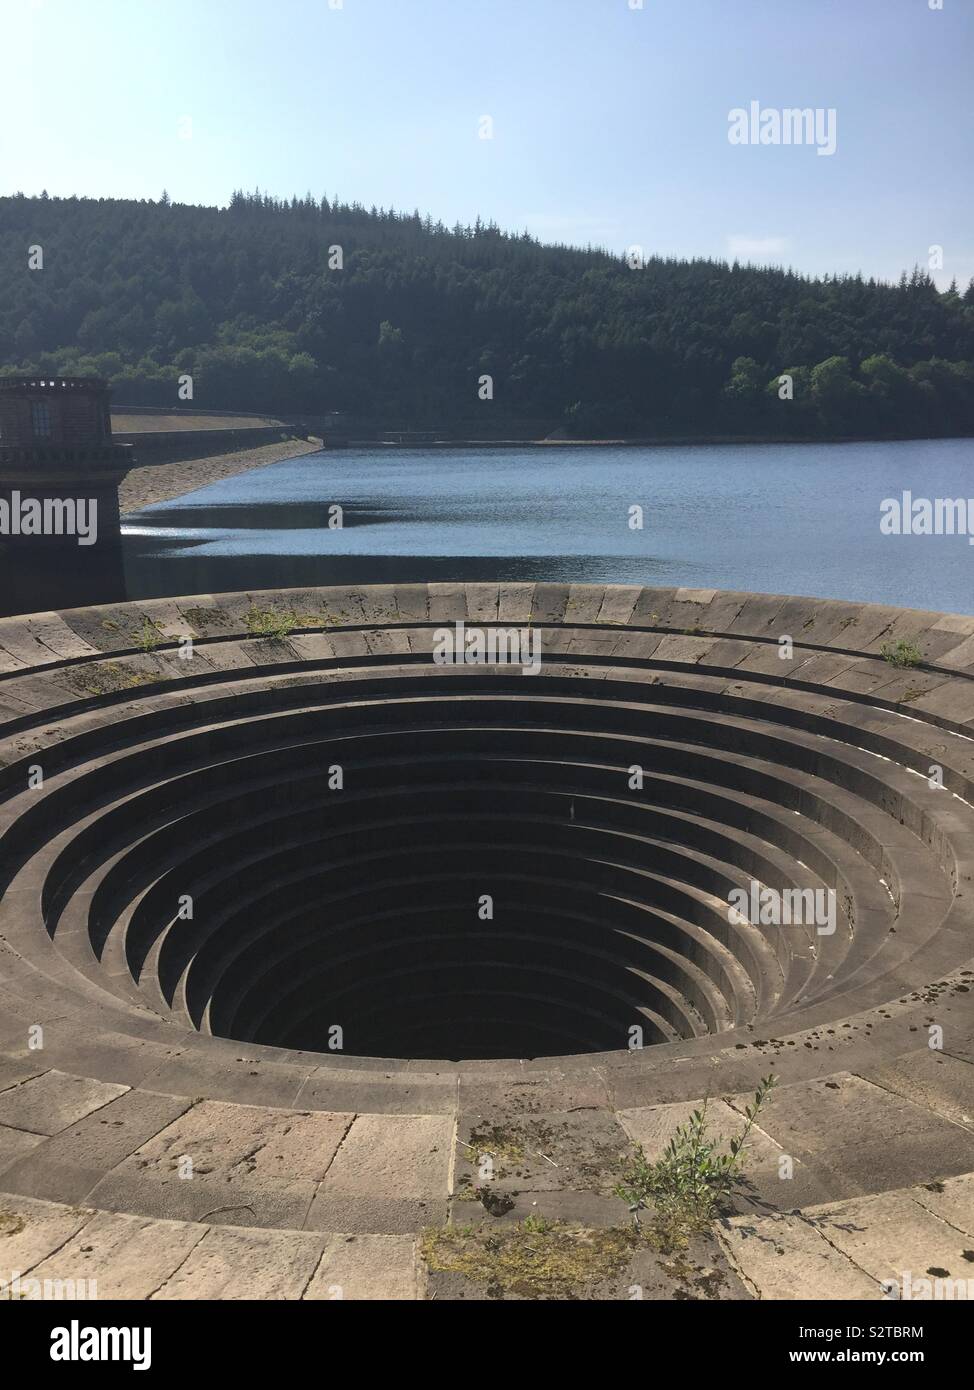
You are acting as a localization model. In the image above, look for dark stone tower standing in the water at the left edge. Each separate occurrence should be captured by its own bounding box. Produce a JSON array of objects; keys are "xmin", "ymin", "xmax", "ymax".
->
[{"xmin": 0, "ymin": 377, "xmax": 133, "ymax": 613}]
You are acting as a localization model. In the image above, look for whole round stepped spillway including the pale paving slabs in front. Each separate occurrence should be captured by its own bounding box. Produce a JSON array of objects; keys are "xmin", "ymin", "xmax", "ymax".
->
[{"xmin": 0, "ymin": 582, "xmax": 974, "ymax": 1273}]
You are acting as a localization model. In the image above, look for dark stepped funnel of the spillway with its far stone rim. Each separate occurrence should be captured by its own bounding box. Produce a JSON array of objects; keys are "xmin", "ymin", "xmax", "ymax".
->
[{"xmin": 0, "ymin": 584, "xmax": 974, "ymax": 1066}]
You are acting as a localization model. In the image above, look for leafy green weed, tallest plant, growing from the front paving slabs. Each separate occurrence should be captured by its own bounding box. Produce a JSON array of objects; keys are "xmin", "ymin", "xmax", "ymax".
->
[{"xmin": 616, "ymin": 1074, "xmax": 775, "ymax": 1252}]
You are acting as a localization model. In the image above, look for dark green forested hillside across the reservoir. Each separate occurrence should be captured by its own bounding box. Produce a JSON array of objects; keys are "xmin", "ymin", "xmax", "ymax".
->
[{"xmin": 0, "ymin": 193, "xmax": 974, "ymax": 438}]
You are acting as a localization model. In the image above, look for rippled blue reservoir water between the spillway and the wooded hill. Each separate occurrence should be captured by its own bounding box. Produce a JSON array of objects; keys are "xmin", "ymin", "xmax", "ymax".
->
[{"xmin": 125, "ymin": 439, "xmax": 974, "ymax": 613}]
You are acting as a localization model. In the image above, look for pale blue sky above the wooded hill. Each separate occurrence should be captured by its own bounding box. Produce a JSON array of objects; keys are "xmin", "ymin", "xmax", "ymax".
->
[{"xmin": 0, "ymin": 0, "xmax": 974, "ymax": 288}]
